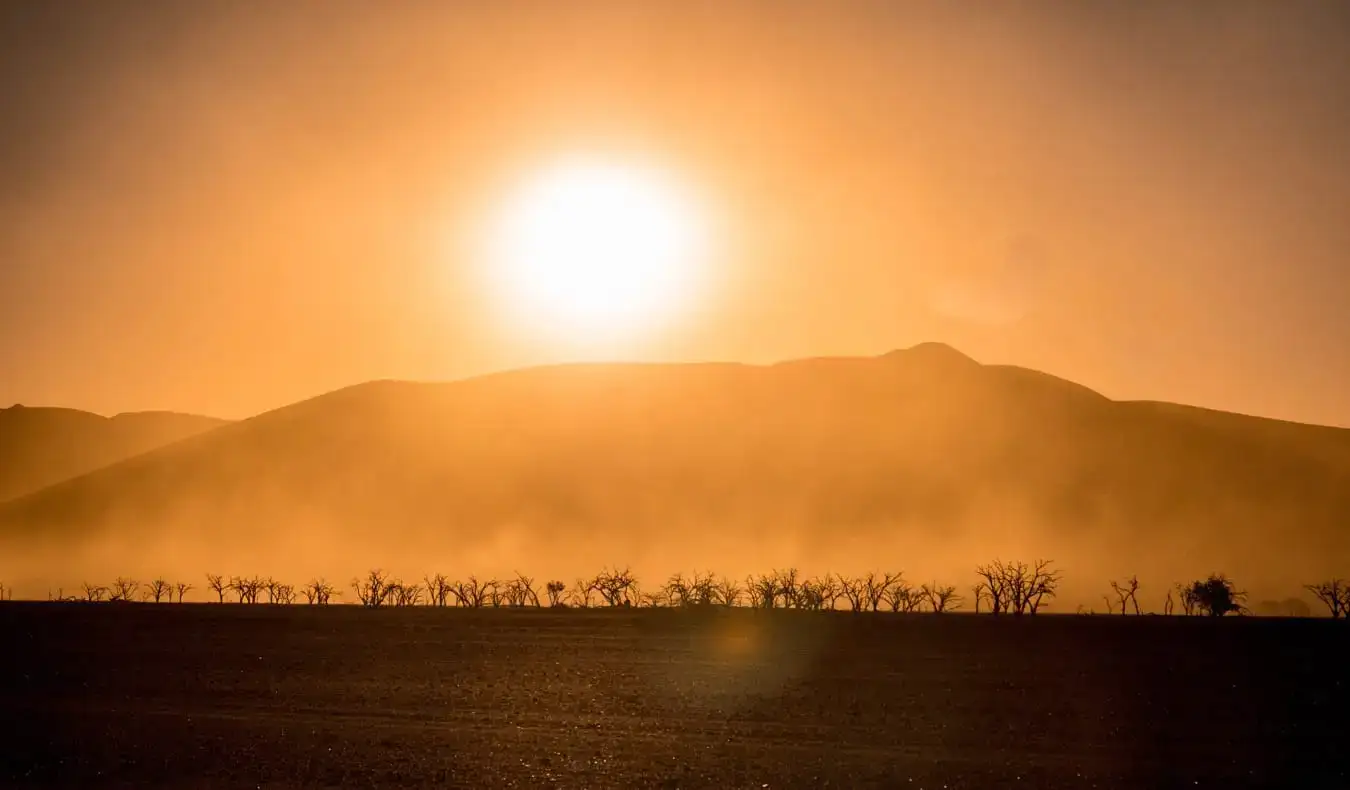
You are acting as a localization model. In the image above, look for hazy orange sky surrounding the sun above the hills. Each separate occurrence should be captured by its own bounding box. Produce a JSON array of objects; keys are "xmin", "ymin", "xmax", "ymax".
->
[{"xmin": 0, "ymin": 0, "xmax": 1350, "ymax": 425}]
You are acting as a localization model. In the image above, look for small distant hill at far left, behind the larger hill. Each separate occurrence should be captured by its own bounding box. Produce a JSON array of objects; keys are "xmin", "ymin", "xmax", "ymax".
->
[{"xmin": 0, "ymin": 405, "xmax": 225, "ymax": 502}]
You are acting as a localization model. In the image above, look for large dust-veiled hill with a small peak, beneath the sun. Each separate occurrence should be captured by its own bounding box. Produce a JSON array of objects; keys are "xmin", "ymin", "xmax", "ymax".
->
[{"xmin": 0, "ymin": 344, "xmax": 1350, "ymax": 602}]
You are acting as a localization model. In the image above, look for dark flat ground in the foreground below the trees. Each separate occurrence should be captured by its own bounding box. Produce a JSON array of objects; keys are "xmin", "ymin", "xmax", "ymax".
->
[{"xmin": 0, "ymin": 604, "xmax": 1350, "ymax": 789}]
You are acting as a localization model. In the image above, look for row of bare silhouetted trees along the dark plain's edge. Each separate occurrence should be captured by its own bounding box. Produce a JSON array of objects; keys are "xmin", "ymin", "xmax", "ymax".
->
[{"xmin": 15, "ymin": 560, "xmax": 1350, "ymax": 618}]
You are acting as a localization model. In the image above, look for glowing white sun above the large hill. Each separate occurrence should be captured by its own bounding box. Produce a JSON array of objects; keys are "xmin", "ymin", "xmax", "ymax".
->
[{"xmin": 486, "ymin": 162, "xmax": 707, "ymax": 343}]
